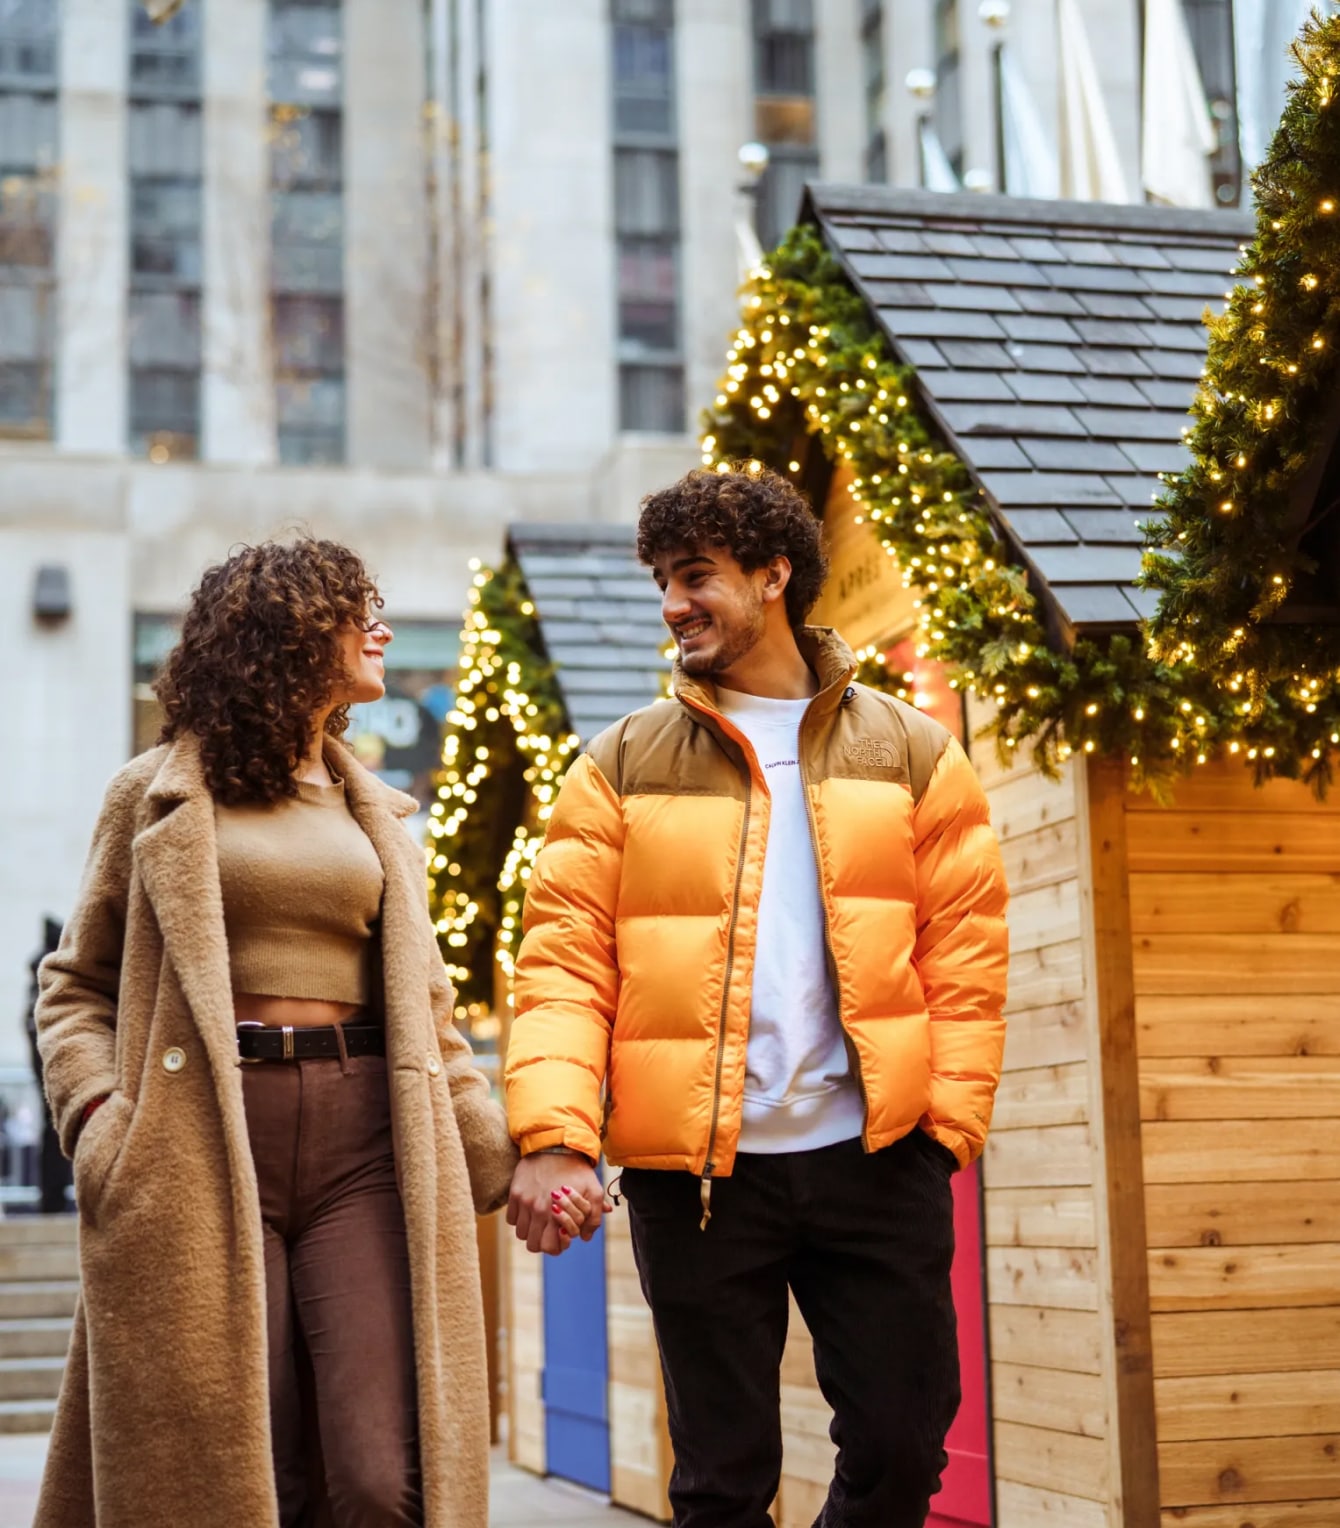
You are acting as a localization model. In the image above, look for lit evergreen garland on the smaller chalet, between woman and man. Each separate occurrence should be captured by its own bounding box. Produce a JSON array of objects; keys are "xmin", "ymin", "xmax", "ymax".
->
[{"xmin": 428, "ymin": 562, "xmax": 578, "ymax": 1019}]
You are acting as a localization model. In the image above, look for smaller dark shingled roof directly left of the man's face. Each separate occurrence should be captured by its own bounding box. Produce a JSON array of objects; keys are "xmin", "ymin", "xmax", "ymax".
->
[{"xmin": 507, "ymin": 524, "xmax": 669, "ymax": 743}]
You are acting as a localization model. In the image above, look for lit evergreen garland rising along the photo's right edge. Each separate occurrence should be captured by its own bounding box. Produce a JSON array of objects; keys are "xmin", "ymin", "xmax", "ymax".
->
[{"xmin": 1146, "ymin": 5, "xmax": 1340, "ymax": 776}]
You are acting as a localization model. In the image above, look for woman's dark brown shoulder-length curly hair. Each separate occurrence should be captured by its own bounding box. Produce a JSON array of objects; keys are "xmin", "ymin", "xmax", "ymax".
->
[{"xmin": 154, "ymin": 536, "xmax": 382, "ymax": 805}]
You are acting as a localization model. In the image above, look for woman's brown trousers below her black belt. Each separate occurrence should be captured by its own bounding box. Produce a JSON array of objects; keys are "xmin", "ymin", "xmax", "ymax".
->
[{"xmin": 243, "ymin": 1056, "xmax": 423, "ymax": 1528}]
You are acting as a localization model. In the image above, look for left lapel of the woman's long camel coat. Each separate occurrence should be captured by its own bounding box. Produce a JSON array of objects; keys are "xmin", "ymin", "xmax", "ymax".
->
[{"xmin": 133, "ymin": 733, "xmax": 237, "ymax": 1089}]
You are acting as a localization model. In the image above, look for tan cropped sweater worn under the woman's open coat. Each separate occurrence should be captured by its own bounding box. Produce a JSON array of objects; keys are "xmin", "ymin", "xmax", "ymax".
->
[{"xmin": 214, "ymin": 781, "xmax": 384, "ymax": 1007}]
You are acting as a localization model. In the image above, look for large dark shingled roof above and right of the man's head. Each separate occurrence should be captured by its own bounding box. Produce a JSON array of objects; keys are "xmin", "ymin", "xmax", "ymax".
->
[{"xmin": 802, "ymin": 185, "xmax": 1254, "ymax": 637}]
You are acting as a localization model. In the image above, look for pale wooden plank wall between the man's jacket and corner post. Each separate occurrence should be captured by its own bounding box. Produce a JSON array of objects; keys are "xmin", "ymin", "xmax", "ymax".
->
[{"xmin": 969, "ymin": 707, "xmax": 1111, "ymax": 1528}]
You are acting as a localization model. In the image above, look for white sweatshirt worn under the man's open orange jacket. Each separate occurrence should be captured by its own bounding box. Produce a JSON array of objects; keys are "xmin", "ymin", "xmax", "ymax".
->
[{"xmin": 717, "ymin": 688, "xmax": 865, "ymax": 1154}]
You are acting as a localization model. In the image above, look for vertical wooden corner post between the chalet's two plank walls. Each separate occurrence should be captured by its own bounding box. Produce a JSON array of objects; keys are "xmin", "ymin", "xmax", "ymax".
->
[{"xmin": 1074, "ymin": 758, "xmax": 1160, "ymax": 1528}]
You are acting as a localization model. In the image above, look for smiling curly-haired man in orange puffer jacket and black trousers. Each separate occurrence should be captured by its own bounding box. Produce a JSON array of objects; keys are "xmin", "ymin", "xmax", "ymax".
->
[{"xmin": 506, "ymin": 471, "xmax": 1007, "ymax": 1528}]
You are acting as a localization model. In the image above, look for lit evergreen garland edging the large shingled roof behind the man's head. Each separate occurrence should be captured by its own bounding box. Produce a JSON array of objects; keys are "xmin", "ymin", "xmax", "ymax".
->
[{"xmin": 703, "ymin": 226, "xmax": 1326, "ymax": 792}]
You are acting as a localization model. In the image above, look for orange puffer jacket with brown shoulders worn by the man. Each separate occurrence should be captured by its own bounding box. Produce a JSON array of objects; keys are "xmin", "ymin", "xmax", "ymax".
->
[{"xmin": 506, "ymin": 628, "xmax": 1008, "ymax": 1180}]
